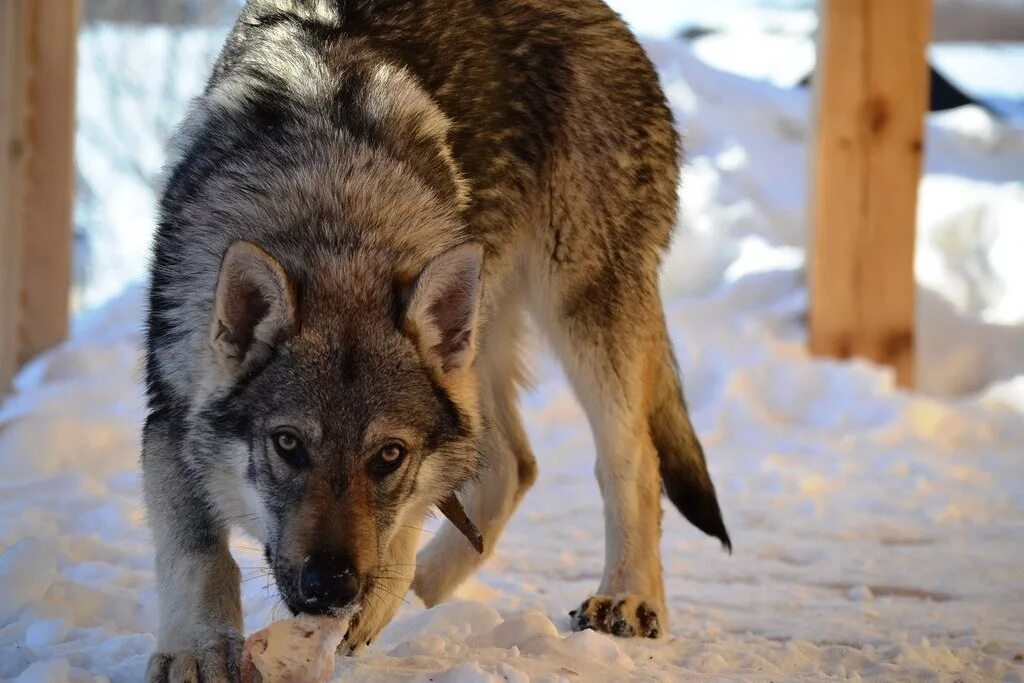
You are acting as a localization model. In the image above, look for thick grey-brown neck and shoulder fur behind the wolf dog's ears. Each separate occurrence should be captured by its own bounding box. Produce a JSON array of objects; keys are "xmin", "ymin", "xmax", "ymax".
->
[{"xmin": 150, "ymin": 2, "xmax": 468, "ymax": 405}]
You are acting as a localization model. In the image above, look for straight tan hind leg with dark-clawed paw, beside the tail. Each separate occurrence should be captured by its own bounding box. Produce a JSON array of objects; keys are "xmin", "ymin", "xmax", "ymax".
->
[{"xmin": 534, "ymin": 258, "xmax": 668, "ymax": 638}]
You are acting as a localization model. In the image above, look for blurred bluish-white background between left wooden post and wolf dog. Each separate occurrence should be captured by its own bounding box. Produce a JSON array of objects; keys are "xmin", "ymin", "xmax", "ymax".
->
[{"xmin": 72, "ymin": 0, "xmax": 242, "ymax": 310}]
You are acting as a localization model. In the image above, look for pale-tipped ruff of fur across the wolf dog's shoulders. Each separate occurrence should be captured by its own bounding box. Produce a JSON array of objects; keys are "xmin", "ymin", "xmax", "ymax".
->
[{"xmin": 207, "ymin": 0, "xmax": 468, "ymax": 209}]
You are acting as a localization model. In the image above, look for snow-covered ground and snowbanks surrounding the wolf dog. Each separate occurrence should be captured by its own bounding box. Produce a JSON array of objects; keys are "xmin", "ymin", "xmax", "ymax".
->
[{"xmin": 0, "ymin": 18, "xmax": 1024, "ymax": 682}]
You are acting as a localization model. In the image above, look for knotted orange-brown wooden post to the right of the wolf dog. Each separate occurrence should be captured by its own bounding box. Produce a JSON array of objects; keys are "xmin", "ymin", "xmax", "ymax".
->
[{"xmin": 809, "ymin": 0, "xmax": 932, "ymax": 386}]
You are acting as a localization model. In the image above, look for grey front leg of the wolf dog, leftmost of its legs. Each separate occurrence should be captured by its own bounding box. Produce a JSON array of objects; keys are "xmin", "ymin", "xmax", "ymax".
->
[{"xmin": 142, "ymin": 418, "xmax": 243, "ymax": 683}]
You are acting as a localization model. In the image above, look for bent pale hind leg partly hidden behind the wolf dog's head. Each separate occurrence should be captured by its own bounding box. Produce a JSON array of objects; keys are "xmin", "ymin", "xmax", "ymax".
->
[{"xmin": 414, "ymin": 302, "xmax": 537, "ymax": 606}]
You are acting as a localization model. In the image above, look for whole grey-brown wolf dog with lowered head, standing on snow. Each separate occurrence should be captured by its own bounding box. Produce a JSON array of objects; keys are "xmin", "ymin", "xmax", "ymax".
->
[{"xmin": 142, "ymin": 0, "xmax": 730, "ymax": 681}]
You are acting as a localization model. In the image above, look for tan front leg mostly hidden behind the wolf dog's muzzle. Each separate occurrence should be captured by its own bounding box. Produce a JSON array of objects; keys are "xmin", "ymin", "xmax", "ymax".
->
[{"xmin": 338, "ymin": 516, "xmax": 423, "ymax": 654}]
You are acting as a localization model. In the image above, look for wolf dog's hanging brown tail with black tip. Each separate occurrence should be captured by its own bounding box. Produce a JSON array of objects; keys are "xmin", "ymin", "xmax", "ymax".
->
[{"xmin": 649, "ymin": 326, "xmax": 732, "ymax": 553}]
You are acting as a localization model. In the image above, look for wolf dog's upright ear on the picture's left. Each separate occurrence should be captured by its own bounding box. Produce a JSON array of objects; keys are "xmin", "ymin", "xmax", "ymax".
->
[{"xmin": 210, "ymin": 241, "xmax": 297, "ymax": 374}]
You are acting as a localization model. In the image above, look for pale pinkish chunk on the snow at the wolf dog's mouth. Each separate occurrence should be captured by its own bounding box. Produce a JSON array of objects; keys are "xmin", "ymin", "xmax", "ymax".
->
[{"xmin": 241, "ymin": 614, "xmax": 348, "ymax": 683}]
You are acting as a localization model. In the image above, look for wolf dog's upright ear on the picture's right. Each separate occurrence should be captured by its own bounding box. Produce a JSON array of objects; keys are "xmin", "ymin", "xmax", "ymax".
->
[{"xmin": 404, "ymin": 242, "xmax": 483, "ymax": 373}]
